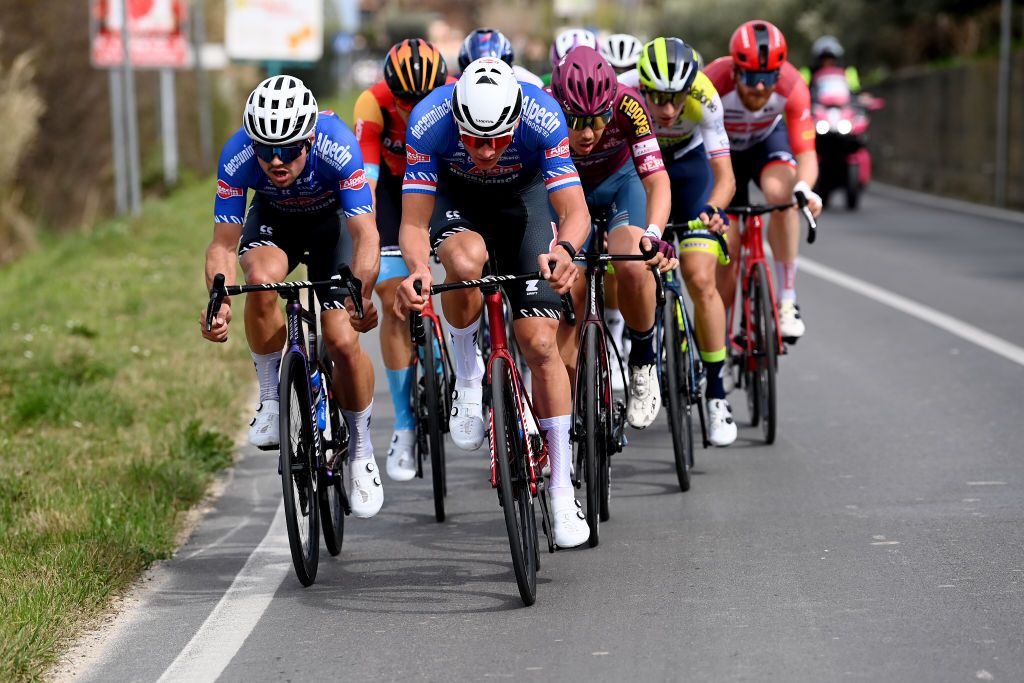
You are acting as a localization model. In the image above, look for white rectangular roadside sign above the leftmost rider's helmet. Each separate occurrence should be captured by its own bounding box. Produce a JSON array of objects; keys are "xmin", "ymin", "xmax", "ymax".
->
[{"xmin": 225, "ymin": 0, "xmax": 324, "ymax": 61}]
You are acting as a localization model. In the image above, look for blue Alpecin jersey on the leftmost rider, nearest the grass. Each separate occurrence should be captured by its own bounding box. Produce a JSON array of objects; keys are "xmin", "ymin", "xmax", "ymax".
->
[{"xmin": 213, "ymin": 112, "xmax": 373, "ymax": 223}]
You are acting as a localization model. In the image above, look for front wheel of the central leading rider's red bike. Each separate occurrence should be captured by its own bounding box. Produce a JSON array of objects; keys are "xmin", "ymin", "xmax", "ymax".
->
[{"xmin": 490, "ymin": 358, "xmax": 539, "ymax": 606}]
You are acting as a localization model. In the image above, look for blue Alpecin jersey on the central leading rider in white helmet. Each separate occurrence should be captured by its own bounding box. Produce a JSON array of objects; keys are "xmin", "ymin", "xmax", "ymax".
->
[{"xmin": 401, "ymin": 83, "xmax": 580, "ymax": 195}]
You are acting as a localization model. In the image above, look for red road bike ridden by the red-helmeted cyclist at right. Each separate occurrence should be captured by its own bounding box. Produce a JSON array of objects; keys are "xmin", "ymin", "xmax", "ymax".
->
[{"xmin": 726, "ymin": 193, "xmax": 817, "ymax": 443}]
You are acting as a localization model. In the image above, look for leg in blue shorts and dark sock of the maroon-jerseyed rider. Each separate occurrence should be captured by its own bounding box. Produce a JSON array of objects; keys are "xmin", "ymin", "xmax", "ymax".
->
[{"xmin": 602, "ymin": 164, "xmax": 662, "ymax": 429}]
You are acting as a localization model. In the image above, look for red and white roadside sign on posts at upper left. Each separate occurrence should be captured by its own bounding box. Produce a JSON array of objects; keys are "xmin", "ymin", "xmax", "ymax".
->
[{"xmin": 91, "ymin": 0, "xmax": 188, "ymax": 69}]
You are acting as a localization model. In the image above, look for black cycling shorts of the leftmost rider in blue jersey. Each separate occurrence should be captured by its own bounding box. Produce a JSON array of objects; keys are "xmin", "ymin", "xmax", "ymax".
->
[{"xmin": 239, "ymin": 194, "xmax": 352, "ymax": 310}]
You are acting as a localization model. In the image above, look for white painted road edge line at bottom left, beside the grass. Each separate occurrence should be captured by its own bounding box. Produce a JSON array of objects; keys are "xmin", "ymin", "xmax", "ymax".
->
[{"xmin": 160, "ymin": 506, "xmax": 292, "ymax": 683}]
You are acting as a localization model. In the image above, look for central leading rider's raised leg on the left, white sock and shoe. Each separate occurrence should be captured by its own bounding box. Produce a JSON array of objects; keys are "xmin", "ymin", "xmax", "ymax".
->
[{"xmin": 430, "ymin": 188, "xmax": 487, "ymax": 451}]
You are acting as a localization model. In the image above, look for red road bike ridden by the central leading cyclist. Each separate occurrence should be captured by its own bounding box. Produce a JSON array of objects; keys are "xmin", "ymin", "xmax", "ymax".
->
[{"xmin": 413, "ymin": 258, "xmax": 574, "ymax": 606}]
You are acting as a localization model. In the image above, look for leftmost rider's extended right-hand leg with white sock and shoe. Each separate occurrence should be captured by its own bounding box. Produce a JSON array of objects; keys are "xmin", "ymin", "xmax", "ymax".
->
[{"xmin": 307, "ymin": 212, "xmax": 384, "ymax": 517}]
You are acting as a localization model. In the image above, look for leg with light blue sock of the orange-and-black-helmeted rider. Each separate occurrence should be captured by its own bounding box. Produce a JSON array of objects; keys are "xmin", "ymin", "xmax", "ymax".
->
[{"xmin": 374, "ymin": 171, "xmax": 416, "ymax": 481}]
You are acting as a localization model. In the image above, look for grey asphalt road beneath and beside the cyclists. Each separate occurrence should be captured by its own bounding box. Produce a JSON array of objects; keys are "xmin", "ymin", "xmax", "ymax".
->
[{"xmin": 68, "ymin": 188, "xmax": 1024, "ymax": 682}]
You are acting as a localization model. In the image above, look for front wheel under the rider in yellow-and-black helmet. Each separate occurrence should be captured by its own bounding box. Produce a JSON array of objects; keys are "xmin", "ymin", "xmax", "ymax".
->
[{"xmin": 662, "ymin": 288, "xmax": 693, "ymax": 490}]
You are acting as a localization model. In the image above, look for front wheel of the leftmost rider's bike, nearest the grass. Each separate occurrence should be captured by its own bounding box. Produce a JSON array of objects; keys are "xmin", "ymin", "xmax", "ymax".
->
[{"xmin": 280, "ymin": 352, "xmax": 319, "ymax": 586}]
